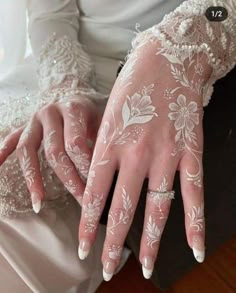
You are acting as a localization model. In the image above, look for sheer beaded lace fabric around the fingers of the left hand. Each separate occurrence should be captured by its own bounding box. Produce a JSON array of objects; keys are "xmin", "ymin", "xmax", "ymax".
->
[{"xmin": 0, "ymin": 94, "xmax": 74, "ymax": 217}]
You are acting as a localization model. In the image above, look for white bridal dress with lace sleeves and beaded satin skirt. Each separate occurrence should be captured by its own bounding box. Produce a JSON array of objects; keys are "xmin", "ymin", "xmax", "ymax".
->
[{"xmin": 0, "ymin": 0, "xmax": 236, "ymax": 293}]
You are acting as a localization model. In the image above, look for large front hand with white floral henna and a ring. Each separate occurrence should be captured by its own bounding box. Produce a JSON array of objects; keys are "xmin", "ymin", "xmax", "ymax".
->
[{"xmin": 79, "ymin": 37, "xmax": 210, "ymax": 281}]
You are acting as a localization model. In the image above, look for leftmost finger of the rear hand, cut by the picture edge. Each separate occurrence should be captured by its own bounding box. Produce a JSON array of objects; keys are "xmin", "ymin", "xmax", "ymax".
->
[{"xmin": 0, "ymin": 127, "xmax": 25, "ymax": 165}]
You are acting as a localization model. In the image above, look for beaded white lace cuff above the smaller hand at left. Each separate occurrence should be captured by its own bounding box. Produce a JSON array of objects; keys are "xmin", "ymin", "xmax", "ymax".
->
[{"xmin": 37, "ymin": 33, "xmax": 94, "ymax": 92}]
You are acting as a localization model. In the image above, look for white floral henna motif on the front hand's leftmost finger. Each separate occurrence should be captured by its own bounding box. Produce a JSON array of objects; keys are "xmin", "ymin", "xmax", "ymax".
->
[{"xmin": 83, "ymin": 194, "xmax": 103, "ymax": 233}]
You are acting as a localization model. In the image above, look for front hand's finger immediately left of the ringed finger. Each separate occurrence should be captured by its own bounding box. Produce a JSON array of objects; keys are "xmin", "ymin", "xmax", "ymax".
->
[{"xmin": 102, "ymin": 160, "xmax": 145, "ymax": 281}]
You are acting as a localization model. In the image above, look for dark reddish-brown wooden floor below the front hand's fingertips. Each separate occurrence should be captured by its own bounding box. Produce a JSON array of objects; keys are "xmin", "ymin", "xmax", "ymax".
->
[{"xmin": 96, "ymin": 236, "xmax": 236, "ymax": 293}]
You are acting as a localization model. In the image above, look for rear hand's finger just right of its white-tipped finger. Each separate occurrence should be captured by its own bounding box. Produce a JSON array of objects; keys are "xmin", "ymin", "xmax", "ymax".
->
[{"xmin": 42, "ymin": 108, "xmax": 85, "ymax": 204}]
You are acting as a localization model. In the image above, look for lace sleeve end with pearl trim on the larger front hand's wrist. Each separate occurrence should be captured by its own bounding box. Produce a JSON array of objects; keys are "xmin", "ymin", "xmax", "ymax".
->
[{"xmin": 133, "ymin": 0, "xmax": 236, "ymax": 106}]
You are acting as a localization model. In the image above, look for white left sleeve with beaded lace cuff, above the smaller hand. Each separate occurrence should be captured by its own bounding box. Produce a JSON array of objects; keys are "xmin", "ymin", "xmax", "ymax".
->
[{"xmin": 28, "ymin": 0, "xmax": 94, "ymax": 92}]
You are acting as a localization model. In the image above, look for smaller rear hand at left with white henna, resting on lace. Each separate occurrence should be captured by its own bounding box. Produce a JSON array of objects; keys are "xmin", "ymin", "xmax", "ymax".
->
[{"xmin": 0, "ymin": 95, "xmax": 100, "ymax": 213}]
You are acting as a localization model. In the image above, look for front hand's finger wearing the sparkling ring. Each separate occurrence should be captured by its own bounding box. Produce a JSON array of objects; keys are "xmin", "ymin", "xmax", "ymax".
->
[{"xmin": 139, "ymin": 154, "xmax": 177, "ymax": 279}]
